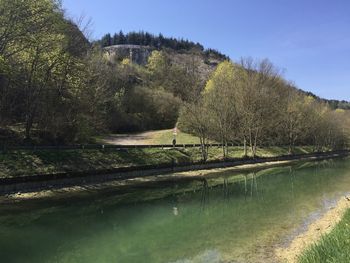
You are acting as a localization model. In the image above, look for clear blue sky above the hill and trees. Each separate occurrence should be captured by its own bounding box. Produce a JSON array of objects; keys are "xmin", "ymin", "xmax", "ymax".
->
[{"xmin": 63, "ymin": 0, "xmax": 350, "ymax": 100}]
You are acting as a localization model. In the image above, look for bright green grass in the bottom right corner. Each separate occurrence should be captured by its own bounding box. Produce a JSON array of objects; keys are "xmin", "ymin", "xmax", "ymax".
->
[{"xmin": 299, "ymin": 209, "xmax": 350, "ymax": 263}]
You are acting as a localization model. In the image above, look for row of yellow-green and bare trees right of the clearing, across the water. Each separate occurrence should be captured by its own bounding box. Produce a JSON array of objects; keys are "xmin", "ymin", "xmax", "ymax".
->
[{"xmin": 180, "ymin": 58, "xmax": 350, "ymax": 157}]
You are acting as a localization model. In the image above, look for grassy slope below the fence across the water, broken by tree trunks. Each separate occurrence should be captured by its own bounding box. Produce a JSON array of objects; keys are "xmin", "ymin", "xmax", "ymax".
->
[{"xmin": 0, "ymin": 147, "xmax": 318, "ymax": 178}]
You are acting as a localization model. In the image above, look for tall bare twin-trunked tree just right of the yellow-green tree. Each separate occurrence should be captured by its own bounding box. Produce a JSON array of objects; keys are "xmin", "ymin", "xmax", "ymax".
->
[{"xmin": 237, "ymin": 58, "xmax": 280, "ymax": 157}]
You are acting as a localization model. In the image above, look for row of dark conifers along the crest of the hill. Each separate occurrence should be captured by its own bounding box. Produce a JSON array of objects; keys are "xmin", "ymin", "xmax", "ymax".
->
[{"xmin": 97, "ymin": 31, "xmax": 229, "ymax": 60}]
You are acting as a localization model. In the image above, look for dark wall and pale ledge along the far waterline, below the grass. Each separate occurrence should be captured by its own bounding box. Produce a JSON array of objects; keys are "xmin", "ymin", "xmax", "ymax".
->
[{"xmin": 0, "ymin": 152, "xmax": 348, "ymax": 202}]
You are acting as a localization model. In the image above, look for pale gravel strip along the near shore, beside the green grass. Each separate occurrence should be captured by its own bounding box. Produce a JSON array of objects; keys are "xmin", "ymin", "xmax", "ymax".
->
[{"xmin": 276, "ymin": 197, "xmax": 350, "ymax": 263}]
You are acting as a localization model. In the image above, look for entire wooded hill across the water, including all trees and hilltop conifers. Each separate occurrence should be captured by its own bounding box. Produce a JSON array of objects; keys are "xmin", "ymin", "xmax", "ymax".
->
[{"xmin": 0, "ymin": 0, "xmax": 350, "ymax": 147}]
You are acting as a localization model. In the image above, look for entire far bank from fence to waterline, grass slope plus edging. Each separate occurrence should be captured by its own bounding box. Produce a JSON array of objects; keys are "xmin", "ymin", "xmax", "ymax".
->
[{"xmin": 0, "ymin": 147, "xmax": 349, "ymax": 194}]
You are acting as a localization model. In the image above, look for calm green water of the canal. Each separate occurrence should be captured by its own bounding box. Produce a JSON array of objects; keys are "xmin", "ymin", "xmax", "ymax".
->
[{"xmin": 0, "ymin": 159, "xmax": 350, "ymax": 263}]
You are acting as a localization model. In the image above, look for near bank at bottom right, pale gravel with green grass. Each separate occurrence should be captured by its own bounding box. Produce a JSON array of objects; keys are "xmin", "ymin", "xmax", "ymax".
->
[{"xmin": 276, "ymin": 197, "xmax": 350, "ymax": 263}]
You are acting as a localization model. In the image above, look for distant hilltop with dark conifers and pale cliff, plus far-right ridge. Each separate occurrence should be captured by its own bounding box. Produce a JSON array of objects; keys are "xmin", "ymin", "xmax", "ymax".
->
[{"xmin": 97, "ymin": 31, "xmax": 350, "ymax": 110}]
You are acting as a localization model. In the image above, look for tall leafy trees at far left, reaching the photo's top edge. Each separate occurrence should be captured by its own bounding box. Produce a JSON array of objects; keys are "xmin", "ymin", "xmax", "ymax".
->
[{"xmin": 0, "ymin": 0, "xmax": 88, "ymax": 142}]
